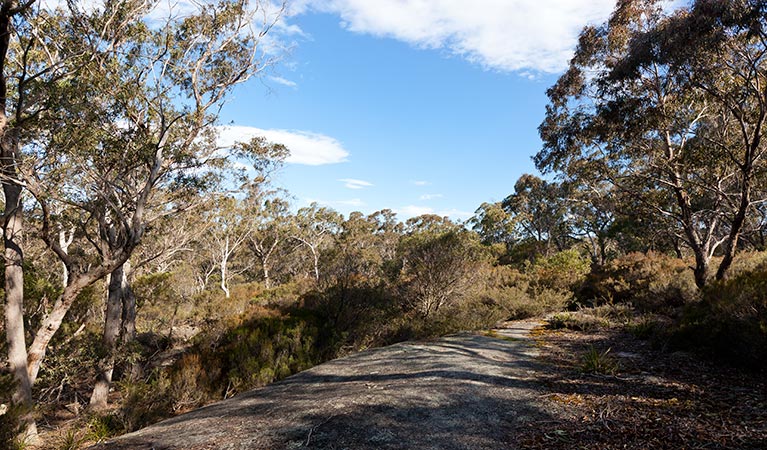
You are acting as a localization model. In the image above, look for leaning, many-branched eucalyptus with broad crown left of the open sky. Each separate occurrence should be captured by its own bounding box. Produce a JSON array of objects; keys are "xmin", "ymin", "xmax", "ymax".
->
[{"xmin": 1, "ymin": 0, "xmax": 290, "ymax": 426}]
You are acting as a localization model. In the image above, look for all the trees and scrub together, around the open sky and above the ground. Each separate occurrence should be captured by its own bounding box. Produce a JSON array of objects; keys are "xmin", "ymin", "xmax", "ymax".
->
[{"xmin": 0, "ymin": 0, "xmax": 767, "ymax": 448}]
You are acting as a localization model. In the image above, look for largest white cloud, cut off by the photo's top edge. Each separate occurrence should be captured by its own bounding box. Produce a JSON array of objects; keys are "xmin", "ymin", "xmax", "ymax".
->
[{"xmin": 296, "ymin": 0, "xmax": 615, "ymax": 73}]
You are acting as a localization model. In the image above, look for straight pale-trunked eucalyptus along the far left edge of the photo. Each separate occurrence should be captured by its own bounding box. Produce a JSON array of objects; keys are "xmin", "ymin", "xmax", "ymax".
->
[{"xmin": 0, "ymin": 0, "xmax": 75, "ymax": 438}]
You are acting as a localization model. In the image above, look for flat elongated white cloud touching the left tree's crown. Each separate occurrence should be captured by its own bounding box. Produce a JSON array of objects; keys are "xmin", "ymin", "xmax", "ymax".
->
[{"xmin": 218, "ymin": 125, "xmax": 349, "ymax": 166}]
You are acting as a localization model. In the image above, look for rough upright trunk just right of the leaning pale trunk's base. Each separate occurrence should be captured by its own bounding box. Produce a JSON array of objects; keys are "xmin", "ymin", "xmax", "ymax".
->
[{"xmin": 88, "ymin": 265, "xmax": 125, "ymax": 411}]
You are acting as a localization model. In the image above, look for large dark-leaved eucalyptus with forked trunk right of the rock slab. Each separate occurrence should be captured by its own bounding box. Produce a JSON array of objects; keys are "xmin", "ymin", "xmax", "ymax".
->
[{"xmin": 536, "ymin": 0, "xmax": 767, "ymax": 287}]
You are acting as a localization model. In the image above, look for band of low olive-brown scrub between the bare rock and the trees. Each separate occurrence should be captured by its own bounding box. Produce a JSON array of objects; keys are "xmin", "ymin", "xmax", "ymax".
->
[{"xmin": 2, "ymin": 207, "xmax": 767, "ymax": 442}]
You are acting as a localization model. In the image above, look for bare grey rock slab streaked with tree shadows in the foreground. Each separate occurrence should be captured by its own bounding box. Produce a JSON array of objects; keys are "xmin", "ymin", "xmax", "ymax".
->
[{"xmin": 95, "ymin": 322, "xmax": 552, "ymax": 450}]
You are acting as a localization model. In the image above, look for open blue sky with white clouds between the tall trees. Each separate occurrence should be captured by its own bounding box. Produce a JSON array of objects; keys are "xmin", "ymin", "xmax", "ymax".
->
[{"xmin": 216, "ymin": 0, "xmax": 624, "ymax": 220}]
